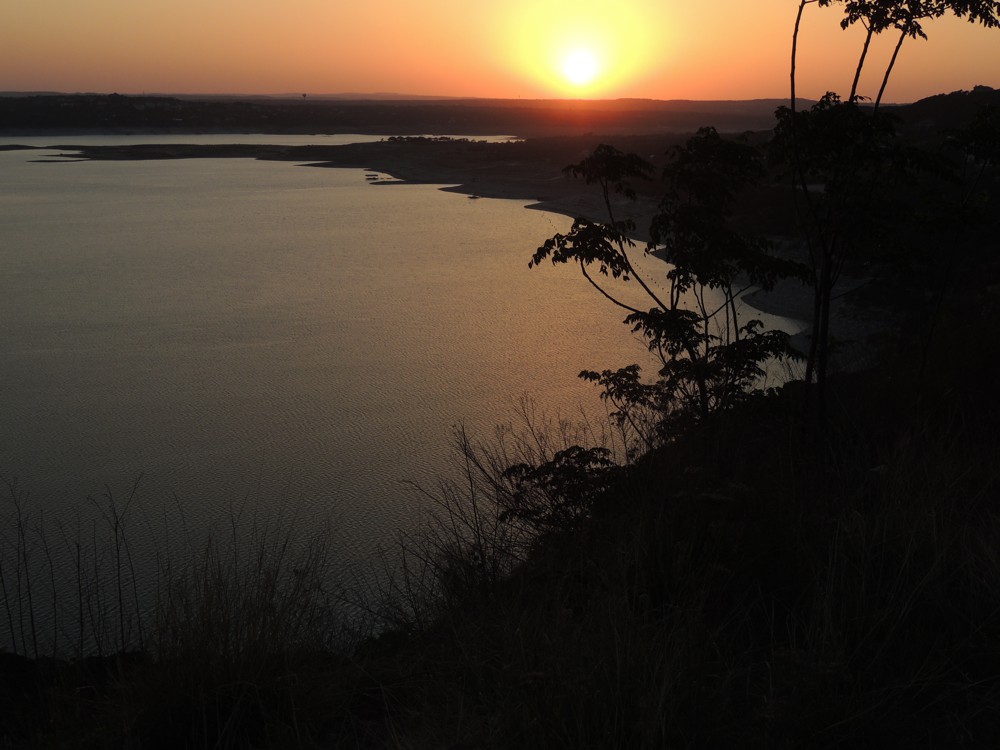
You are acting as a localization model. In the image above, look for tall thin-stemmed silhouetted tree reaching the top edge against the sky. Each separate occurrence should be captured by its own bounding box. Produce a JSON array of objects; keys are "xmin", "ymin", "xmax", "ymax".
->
[{"xmin": 773, "ymin": 0, "xmax": 1000, "ymax": 419}]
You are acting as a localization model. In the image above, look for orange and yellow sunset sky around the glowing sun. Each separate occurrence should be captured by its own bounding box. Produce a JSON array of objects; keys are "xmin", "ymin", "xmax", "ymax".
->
[{"xmin": 0, "ymin": 0, "xmax": 1000, "ymax": 102}]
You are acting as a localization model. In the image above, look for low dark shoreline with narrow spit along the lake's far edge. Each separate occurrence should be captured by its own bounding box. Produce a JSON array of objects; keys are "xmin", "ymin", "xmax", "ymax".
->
[{"xmin": 0, "ymin": 133, "xmax": 890, "ymax": 369}]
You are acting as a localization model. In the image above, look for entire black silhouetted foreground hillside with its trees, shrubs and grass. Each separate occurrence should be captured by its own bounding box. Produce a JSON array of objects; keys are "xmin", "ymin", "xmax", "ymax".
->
[{"xmin": 0, "ymin": 0, "xmax": 1000, "ymax": 748}]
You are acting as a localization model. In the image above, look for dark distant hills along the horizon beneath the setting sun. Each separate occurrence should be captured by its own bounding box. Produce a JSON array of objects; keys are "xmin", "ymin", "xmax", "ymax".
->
[{"xmin": 0, "ymin": 86, "xmax": 1000, "ymax": 136}]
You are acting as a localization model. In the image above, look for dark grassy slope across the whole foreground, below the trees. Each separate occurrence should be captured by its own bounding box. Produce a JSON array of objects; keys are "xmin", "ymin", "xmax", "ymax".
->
[{"xmin": 0, "ymin": 302, "xmax": 1000, "ymax": 748}]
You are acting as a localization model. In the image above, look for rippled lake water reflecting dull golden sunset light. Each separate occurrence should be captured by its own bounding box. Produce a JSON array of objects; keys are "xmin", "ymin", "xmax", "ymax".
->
[{"xmin": 0, "ymin": 136, "xmax": 796, "ymax": 652}]
